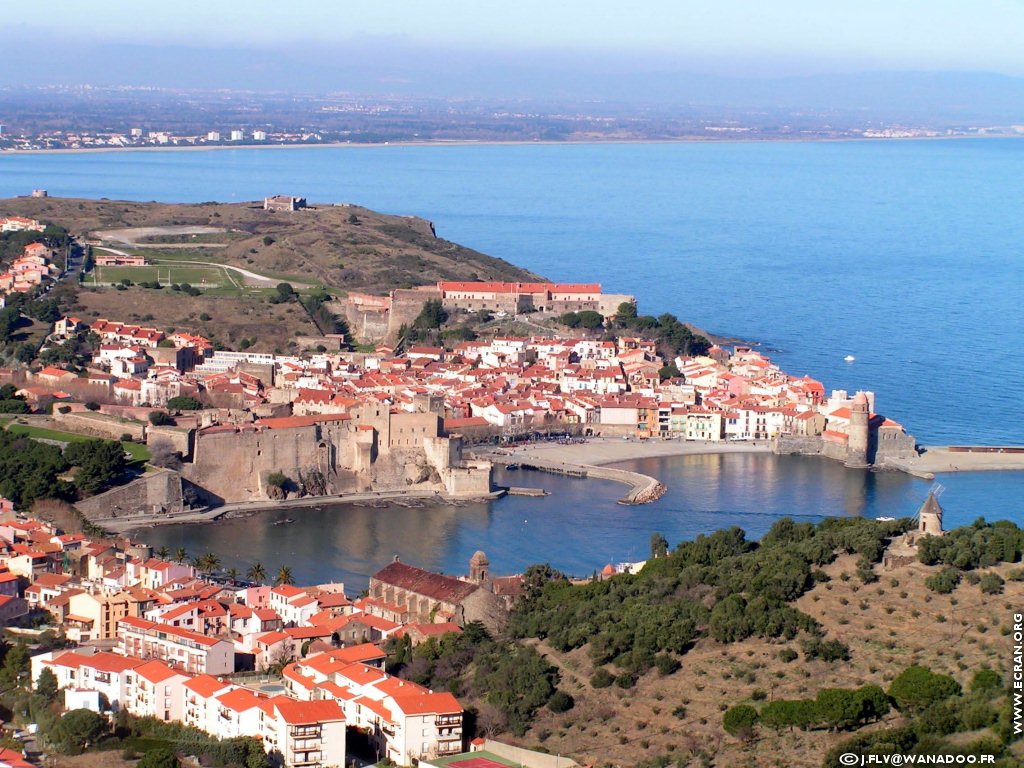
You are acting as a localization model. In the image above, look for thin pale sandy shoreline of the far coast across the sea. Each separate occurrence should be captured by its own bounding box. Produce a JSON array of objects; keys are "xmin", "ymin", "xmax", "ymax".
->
[{"xmin": 0, "ymin": 134, "xmax": 1024, "ymax": 158}]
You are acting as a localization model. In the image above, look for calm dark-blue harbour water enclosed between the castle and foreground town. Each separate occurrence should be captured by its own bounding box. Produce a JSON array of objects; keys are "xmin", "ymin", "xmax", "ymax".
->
[{"xmin": 137, "ymin": 454, "xmax": 1024, "ymax": 589}]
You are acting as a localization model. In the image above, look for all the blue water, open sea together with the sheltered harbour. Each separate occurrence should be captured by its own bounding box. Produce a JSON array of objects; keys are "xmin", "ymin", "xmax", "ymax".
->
[{"xmin": 0, "ymin": 139, "xmax": 1024, "ymax": 584}]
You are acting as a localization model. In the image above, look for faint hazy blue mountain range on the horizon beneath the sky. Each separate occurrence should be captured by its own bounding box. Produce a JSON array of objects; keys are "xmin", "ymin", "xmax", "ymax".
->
[{"xmin": 6, "ymin": 39, "xmax": 1024, "ymax": 126}]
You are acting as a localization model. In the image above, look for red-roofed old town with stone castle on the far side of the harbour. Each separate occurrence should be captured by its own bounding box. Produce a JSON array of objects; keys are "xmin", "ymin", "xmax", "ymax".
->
[{"xmin": 6, "ymin": 288, "xmax": 915, "ymax": 520}]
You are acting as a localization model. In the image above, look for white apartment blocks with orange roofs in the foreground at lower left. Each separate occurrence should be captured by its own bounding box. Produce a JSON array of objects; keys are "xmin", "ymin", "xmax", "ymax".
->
[{"xmin": 9, "ymin": 508, "xmax": 499, "ymax": 768}]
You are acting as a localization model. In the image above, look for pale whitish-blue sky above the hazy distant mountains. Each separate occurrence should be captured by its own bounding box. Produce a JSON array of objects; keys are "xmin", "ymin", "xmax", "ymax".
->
[{"xmin": 3, "ymin": 0, "xmax": 1024, "ymax": 76}]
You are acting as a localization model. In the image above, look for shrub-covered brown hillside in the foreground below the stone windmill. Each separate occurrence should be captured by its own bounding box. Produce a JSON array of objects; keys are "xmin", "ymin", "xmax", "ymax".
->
[{"xmin": 392, "ymin": 518, "xmax": 1024, "ymax": 768}]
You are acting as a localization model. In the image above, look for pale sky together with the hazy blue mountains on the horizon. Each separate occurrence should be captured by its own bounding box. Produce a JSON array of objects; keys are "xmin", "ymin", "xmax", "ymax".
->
[{"xmin": 0, "ymin": 0, "xmax": 1024, "ymax": 124}]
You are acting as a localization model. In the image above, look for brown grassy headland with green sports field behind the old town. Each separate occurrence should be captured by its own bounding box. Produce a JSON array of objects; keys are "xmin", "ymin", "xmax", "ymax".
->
[{"xmin": 0, "ymin": 198, "xmax": 537, "ymax": 353}]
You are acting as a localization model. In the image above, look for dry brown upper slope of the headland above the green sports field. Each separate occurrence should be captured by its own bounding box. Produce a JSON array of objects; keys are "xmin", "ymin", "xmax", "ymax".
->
[{"xmin": 0, "ymin": 198, "xmax": 537, "ymax": 293}]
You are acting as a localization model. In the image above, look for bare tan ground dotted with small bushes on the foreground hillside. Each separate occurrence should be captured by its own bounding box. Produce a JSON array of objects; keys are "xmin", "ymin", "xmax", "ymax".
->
[{"xmin": 513, "ymin": 555, "xmax": 1024, "ymax": 768}]
